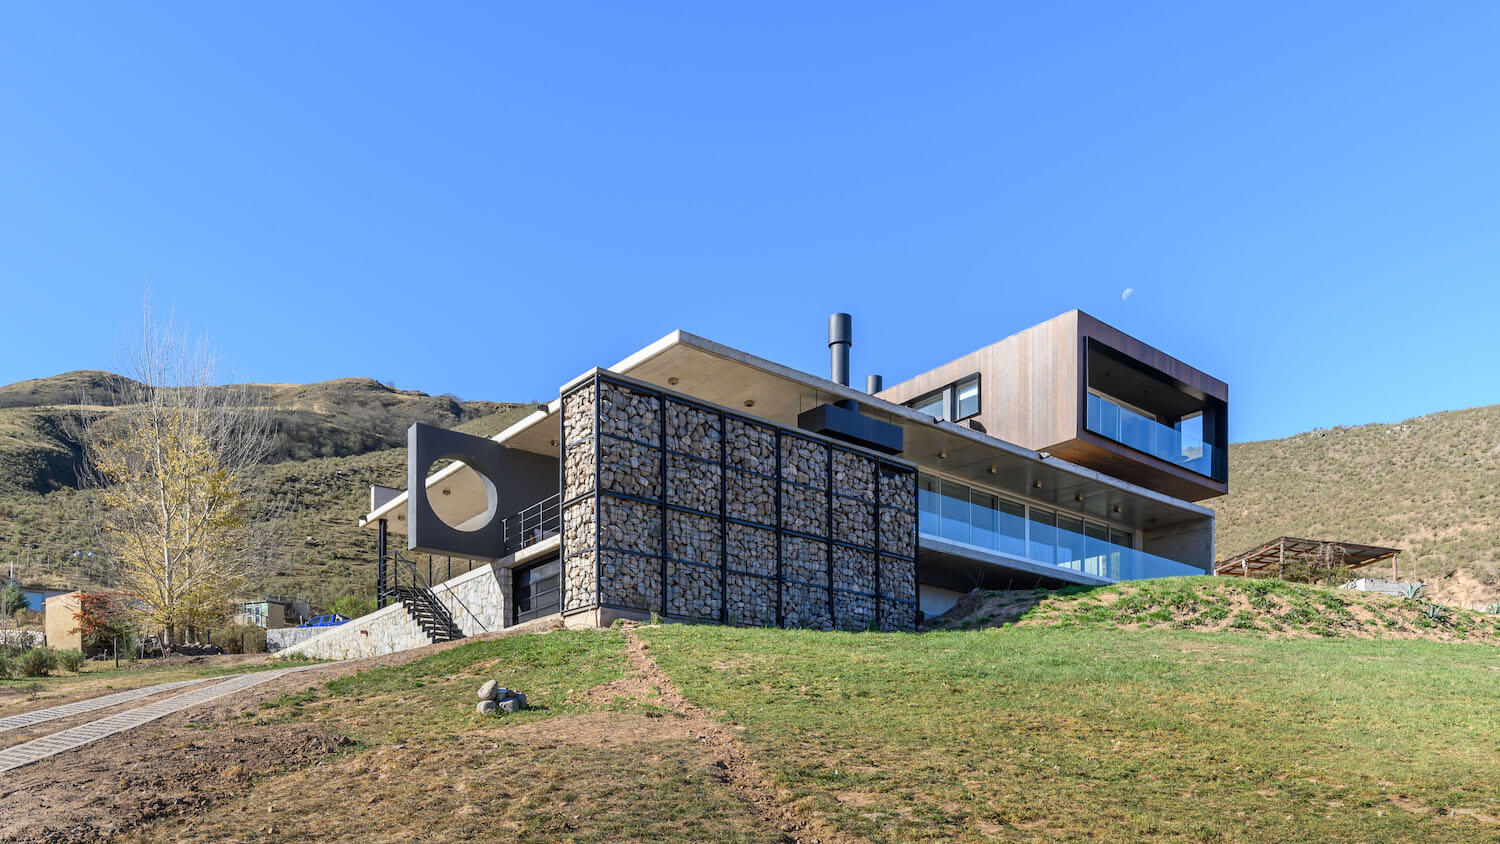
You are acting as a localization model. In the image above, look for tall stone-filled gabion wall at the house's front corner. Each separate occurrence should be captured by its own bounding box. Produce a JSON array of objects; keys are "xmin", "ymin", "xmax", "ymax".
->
[{"xmin": 560, "ymin": 372, "xmax": 917, "ymax": 631}]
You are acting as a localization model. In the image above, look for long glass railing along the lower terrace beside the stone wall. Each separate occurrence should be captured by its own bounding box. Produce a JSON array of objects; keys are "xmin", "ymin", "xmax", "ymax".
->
[{"xmin": 918, "ymin": 478, "xmax": 1203, "ymax": 580}]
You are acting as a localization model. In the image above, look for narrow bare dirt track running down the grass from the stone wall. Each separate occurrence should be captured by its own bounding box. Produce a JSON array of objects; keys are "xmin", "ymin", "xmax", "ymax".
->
[{"xmin": 618, "ymin": 625, "xmax": 861, "ymax": 843}]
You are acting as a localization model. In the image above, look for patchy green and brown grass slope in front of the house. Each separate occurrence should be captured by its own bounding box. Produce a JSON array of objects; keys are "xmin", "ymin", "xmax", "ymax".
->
[{"xmin": 43, "ymin": 625, "xmax": 1500, "ymax": 841}]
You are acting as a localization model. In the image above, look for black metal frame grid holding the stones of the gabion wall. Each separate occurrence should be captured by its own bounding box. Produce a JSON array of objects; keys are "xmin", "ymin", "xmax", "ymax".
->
[{"xmin": 558, "ymin": 372, "xmax": 920, "ymax": 628}]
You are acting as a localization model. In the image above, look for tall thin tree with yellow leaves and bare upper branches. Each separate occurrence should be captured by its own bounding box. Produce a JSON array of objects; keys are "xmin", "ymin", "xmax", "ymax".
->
[{"xmin": 78, "ymin": 309, "xmax": 275, "ymax": 643}]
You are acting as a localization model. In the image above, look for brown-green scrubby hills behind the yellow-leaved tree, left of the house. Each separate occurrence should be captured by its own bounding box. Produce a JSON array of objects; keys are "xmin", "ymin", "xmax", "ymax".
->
[{"xmin": 0, "ymin": 372, "xmax": 531, "ymax": 601}]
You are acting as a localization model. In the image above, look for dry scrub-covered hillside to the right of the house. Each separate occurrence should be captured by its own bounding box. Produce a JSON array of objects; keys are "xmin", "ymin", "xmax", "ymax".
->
[{"xmin": 1206, "ymin": 405, "xmax": 1500, "ymax": 606}]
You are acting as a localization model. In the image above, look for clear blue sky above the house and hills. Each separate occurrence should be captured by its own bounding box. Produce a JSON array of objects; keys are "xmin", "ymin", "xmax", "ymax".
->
[{"xmin": 0, "ymin": 1, "xmax": 1500, "ymax": 441}]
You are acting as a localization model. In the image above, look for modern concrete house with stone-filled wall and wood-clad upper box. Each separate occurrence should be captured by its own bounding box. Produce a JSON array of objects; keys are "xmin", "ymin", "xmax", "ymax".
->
[{"xmin": 276, "ymin": 310, "xmax": 1229, "ymax": 655}]
